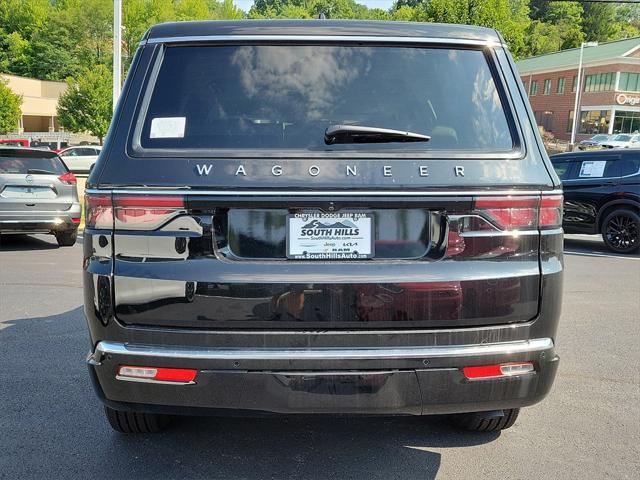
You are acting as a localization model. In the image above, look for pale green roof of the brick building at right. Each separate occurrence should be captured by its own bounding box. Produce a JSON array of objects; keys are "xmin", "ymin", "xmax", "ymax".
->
[{"xmin": 516, "ymin": 37, "xmax": 640, "ymax": 75}]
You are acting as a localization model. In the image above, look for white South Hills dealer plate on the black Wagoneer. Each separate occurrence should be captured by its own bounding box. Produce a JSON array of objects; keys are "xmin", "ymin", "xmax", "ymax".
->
[{"xmin": 287, "ymin": 212, "xmax": 374, "ymax": 260}]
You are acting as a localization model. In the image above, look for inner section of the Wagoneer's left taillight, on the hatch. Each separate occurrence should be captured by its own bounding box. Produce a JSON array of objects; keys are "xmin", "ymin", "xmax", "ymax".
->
[{"xmin": 113, "ymin": 195, "xmax": 185, "ymax": 230}]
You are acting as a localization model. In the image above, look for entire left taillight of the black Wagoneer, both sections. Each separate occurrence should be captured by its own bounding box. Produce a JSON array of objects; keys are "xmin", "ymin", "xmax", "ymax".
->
[{"xmin": 85, "ymin": 194, "xmax": 186, "ymax": 230}]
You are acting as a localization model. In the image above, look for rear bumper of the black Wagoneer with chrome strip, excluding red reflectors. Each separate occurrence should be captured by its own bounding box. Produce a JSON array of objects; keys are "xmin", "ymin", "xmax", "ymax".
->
[{"xmin": 88, "ymin": 338, "xmax": 558, "ymax": 415}]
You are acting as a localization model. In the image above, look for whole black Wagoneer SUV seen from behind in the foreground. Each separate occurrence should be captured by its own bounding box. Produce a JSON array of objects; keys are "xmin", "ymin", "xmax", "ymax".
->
[{"xmin": 84, "ymin": 20, "xmax": 563, "ymax": 432}]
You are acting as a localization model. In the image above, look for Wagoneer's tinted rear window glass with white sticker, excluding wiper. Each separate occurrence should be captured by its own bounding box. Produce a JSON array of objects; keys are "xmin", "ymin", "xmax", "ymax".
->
[{"xmin": 140, "ymin": 45, "xmax": 514, "ymax": 151}]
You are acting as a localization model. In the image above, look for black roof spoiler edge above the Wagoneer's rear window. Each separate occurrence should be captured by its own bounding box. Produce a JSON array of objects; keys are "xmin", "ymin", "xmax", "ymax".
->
[{"xmin": 145, "ymin": 20, "xmax": 502, "ymax": 43}]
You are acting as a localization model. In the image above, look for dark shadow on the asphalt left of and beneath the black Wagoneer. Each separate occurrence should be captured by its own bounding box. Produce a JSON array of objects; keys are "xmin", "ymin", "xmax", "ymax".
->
[{"xmin": 0, "ymin": 307, "xmax": 499, "ymax": 479}]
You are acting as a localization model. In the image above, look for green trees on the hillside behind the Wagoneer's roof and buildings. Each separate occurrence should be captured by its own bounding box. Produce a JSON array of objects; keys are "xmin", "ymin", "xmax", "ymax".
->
[{"xmin": 0, "ymin": 0, "xmax": 640, "ymax": 80}]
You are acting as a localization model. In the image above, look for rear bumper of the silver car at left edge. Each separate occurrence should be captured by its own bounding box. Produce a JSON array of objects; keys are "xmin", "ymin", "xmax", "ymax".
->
[{"xmin": 0, "ymin": 208, "xmax": 82, "ymax": 233}]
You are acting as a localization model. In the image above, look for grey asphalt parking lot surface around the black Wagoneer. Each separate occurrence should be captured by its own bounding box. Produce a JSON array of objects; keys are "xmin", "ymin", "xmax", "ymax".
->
[{"xmin": 0, "ymin": 232, "xmax": 640, "ymax": 480}]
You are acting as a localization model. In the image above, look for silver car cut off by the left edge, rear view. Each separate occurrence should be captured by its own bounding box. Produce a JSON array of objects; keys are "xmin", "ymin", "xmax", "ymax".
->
[{"xmin": 0, "ymin": 147, "xmax": 81, "ymax": 246}]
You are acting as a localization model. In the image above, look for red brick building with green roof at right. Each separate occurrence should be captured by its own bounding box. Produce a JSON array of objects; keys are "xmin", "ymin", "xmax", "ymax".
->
[{"xmin": 516, "ymin": 37, "xmax": 640, "ymax": 141}]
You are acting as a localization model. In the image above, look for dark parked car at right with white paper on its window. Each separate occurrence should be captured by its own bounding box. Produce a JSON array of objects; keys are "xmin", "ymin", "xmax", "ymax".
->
[{"xmin": 551, "ymin": 149, "xmax": 640, "ymax": 253}]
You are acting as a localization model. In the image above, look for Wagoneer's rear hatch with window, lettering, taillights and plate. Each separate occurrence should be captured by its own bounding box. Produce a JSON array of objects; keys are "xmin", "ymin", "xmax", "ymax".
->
[{"xmin": 86, "ymin": 44, "xmax": 561, "ymax": 329}]
